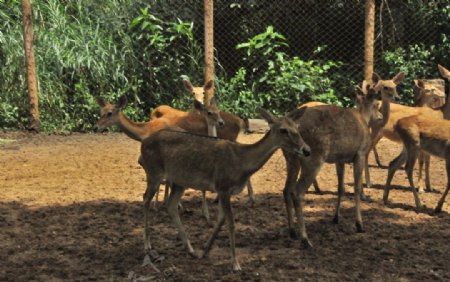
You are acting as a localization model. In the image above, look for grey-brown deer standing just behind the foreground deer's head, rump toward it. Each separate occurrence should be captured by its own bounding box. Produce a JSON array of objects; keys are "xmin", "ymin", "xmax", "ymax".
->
[{"xmin": 283, "ymin": 72, "xmax": 404, "ymax": 248}]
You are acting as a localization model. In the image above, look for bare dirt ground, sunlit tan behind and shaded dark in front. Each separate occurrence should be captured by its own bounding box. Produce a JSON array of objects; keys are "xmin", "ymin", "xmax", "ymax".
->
[{"xmin": 0, "ymin": 133, "xmax": 450, "ymax": 281}]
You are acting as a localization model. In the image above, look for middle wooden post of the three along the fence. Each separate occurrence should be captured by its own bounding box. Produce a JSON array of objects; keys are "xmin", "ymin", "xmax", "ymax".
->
[{"xmin": 204, "ymin": 0, "xmax": 214, "ymax": 105}]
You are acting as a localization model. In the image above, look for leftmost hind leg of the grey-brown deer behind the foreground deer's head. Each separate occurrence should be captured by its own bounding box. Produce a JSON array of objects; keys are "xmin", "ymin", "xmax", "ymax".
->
[{"xmin": 283, "ymin": 150, "xmax": 300, "ymax": 238}]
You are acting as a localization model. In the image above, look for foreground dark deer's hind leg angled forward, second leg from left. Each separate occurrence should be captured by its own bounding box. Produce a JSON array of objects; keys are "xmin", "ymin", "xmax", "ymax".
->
[{"xmin": 167, "ymin": 183, "xmax": 198, "ymax": 257}]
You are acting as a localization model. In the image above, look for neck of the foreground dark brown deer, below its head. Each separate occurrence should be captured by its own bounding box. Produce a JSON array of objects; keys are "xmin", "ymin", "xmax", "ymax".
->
[{"xmin": 239, "ymin": 131, "xmax": 280, "ymax": 174}]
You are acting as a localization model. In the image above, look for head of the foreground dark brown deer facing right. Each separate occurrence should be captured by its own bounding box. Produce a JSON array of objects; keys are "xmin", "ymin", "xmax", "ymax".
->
[{"xmin": 266, "ymin": 108, "xmax": 311, "ymax": 157}]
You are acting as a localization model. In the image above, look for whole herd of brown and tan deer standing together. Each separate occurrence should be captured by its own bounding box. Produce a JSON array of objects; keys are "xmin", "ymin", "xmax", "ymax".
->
[{"xmin": 97, "ymin": 65, "xmax": 450, "ymax": 270}]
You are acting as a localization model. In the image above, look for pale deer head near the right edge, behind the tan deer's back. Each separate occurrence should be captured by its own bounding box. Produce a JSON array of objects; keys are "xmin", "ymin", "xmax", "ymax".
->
[{"xmin": 414, "ymin": 79, "xmax": 445, "ymax": 109}]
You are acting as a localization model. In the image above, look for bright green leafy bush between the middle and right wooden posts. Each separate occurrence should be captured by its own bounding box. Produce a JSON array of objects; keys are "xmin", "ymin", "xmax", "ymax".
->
[{"xmin": 220, "ymin": 26, "xmax": 340, "ymax": 118}]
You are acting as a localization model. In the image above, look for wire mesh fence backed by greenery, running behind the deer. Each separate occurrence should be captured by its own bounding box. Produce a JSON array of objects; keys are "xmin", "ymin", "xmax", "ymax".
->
[{"xmin": 0, "ymin": 0, "xmax": 450, "ymax": 129}]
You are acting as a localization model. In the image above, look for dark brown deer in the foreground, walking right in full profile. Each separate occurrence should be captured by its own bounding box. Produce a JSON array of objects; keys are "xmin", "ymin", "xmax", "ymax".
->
[{"xmin": 141, "ymin": 109, "xmax": 311, "ymax": 271}]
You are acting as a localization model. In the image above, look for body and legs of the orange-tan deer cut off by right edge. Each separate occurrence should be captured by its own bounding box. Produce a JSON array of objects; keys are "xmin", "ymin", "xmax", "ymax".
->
[{"xmin": 383, "ymin": 115, "xmax": 450, "ymax": 213}]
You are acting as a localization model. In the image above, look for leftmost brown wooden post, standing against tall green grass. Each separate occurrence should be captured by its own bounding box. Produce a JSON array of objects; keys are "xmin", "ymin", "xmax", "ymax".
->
[{"xmin": 22, "ymin": 0, "xmax": 40, "ymax": 131}]
